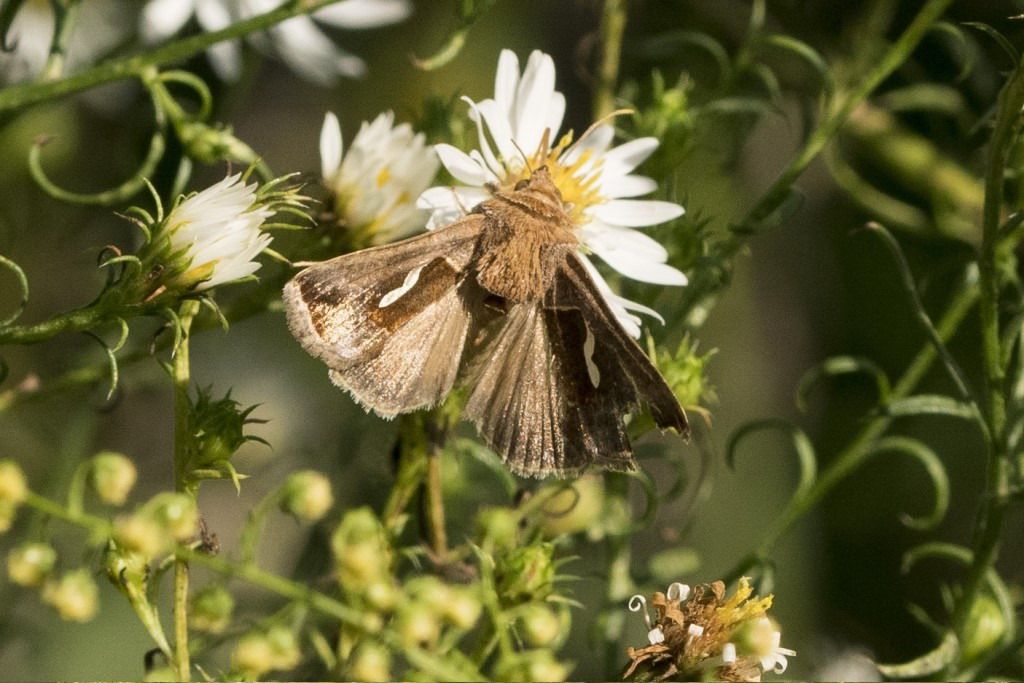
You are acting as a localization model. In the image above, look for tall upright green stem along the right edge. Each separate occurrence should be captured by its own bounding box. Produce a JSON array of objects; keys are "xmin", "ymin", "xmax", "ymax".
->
[{"xmin": 953, "ymin": 54, "xmax": 1024, "ymax": 642}]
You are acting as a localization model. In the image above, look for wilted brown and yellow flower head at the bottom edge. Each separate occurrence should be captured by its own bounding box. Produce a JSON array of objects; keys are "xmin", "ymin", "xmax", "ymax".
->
[{"xmin": 623, "ymin": 577, "xmax": 796, "ymax": 681}]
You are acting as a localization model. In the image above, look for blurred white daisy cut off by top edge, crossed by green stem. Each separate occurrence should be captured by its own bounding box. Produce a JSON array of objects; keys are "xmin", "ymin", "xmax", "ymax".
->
[{"xmin": 139, "ymin": 0, "xmax": 413, "ymax": 85}]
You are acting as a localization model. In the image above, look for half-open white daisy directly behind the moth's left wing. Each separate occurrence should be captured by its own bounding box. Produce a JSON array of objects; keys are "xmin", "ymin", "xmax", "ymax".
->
[{"xmin": 319, "ymin": 112, "xmax": 440, "ymax": 244}]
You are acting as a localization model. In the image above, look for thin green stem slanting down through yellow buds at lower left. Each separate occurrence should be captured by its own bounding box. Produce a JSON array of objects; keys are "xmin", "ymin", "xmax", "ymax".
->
[{"xmin": 25, "ymin": 492, "xmax": 484, "ymax": 681}]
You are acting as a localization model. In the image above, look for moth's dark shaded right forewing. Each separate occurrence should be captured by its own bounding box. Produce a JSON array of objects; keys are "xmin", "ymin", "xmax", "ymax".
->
[{"xmin": 545, "ymin": 252, "xmax": 689, "ymax": 437}]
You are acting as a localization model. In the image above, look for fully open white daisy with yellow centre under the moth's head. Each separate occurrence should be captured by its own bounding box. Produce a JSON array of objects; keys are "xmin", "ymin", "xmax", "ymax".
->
[{"xmin": 419, "ymin": 50, "xmax": 686, "ymax": 337}]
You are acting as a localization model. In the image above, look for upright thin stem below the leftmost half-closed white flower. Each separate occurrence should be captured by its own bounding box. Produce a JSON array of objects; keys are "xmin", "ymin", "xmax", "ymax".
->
[{"xmin": 171, "ymin": 301, "xmax": 200, "ymax": 681}]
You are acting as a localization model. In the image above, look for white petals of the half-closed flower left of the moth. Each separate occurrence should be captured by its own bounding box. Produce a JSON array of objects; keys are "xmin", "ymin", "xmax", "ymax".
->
[{"xmin": 162, "ymin": 173, "xmax": 273, "ymax": 291}]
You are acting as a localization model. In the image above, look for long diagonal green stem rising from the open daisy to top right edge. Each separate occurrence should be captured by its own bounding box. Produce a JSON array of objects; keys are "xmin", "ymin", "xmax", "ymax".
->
[{"xmin": 683, "ymin": 0, "xmax": 952, "ymax": 325}]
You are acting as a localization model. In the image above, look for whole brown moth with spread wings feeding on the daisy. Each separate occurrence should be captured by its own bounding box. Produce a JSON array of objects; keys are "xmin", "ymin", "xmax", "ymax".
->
[{"xmin": 285, "ymin": 168, "xmax": 689, "ymax": 476}]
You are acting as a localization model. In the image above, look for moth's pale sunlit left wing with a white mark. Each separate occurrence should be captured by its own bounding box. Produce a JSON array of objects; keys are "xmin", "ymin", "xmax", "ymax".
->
[{"xmin": 285, "ymin": 216, "xmax": 482, "ymax": 417}]
